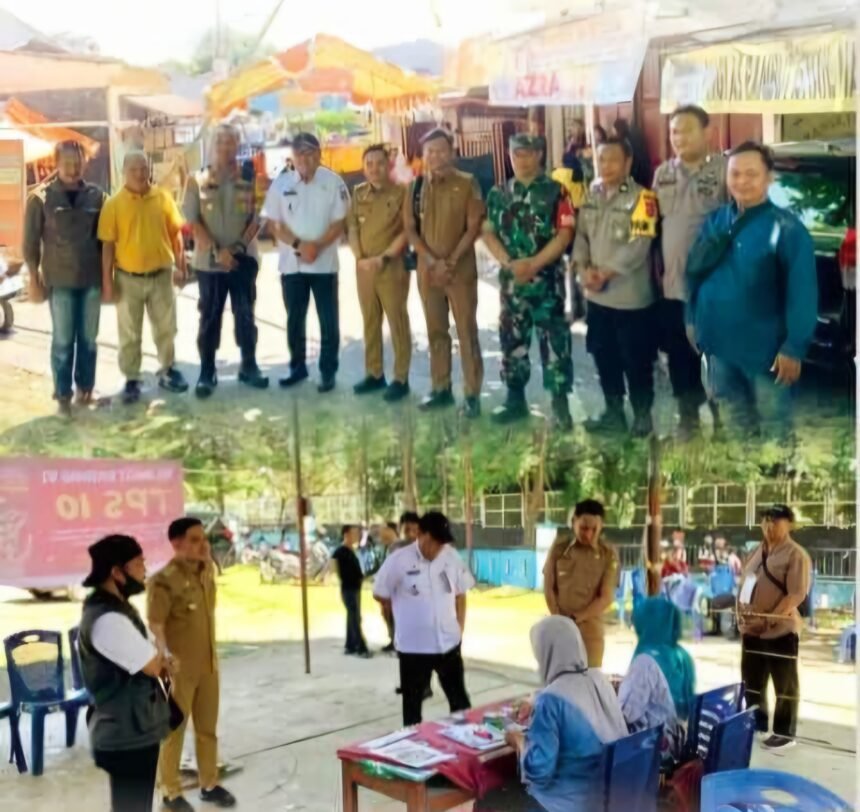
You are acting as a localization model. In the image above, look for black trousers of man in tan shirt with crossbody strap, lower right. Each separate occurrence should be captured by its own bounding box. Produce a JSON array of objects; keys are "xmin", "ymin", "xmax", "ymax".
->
[{"xmin": 741, "ymin": 634, "xmax": 800, "ymax": 738}]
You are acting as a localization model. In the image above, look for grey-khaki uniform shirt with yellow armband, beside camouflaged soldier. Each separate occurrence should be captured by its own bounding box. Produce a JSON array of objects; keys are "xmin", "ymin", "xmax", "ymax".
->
[{"xmin": 573, "ymin": 180, "xmax": 658, "ymax": 310}]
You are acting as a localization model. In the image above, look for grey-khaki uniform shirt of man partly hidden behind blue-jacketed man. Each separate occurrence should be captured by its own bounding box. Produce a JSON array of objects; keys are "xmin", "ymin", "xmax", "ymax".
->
[{"xmin": 654, "ymin": 153, "xmax": 729, "ymax": 301}]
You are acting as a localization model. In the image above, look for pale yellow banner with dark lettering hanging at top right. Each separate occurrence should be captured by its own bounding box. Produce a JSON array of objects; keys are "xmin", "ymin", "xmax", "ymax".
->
[{"xmin": 660, "ymin": 29, "xmax": 857, "ymax": 114}]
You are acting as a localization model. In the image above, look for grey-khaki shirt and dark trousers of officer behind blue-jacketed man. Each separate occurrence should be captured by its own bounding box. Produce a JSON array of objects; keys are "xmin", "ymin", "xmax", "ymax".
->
[{"xmin": 653, "ymin": 154, "xmax": 728, "ymax": 428}]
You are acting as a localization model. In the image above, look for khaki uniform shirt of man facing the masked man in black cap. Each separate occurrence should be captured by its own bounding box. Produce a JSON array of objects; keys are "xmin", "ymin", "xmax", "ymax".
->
[{"xmin": 147, "ymin": 559, "xmax": 218, "ymax": 675}]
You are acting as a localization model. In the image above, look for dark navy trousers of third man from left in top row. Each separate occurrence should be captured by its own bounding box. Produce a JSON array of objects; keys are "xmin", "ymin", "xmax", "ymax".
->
[{"xmin": 197, "ymin": 269, "xmax": 257, "ymax": 377}]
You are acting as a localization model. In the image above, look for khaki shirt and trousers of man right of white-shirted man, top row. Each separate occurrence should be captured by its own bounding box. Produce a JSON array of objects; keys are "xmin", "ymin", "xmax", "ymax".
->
[{"xmin": 347, "ymin": 183, "xmax": 412, "ymax": 383}]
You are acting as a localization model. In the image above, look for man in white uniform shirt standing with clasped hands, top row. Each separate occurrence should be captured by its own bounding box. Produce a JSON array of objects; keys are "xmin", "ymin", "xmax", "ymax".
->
[{"xmin": 262, "ymin": 133, "xmax": 349, "ymax": 392}]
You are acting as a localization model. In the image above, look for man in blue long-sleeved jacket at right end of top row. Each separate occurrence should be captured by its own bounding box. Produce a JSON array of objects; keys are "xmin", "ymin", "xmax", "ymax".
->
[{"xmin": 687, "ymin": 141, "xmax": 818, "ymax": 437}]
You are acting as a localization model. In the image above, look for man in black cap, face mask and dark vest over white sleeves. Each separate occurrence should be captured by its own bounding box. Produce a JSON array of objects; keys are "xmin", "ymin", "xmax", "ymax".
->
[{"xmin": 80, "ymin": 536, "xmax": 170, "ymax": 812}]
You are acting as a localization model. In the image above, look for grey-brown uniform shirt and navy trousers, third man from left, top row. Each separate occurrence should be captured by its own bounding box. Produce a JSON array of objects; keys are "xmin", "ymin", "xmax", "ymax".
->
[{"xmin": 184, "ymin": 168, "xmax": 268, "ymax": 391}]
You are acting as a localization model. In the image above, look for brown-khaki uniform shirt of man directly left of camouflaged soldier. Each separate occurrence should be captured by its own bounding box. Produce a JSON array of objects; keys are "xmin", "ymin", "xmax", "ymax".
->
[{"xmin": 408, "ymin": 169, "xmax": 483, "ymax": 274}]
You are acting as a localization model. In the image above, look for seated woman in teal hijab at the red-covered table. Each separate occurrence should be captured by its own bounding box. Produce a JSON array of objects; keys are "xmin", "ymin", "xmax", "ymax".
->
[{"xmin": 618, "ymin": 597, "xmax": 696, "ymax": 763}]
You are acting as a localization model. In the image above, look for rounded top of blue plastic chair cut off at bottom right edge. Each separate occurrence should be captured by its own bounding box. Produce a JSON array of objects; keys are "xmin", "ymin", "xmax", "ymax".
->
[{"xmin": 701, "ymin": 770, "xmax": 854, "ymax": 812}]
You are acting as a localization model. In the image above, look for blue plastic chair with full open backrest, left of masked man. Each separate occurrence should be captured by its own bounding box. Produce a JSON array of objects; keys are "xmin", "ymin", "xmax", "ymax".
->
[{"xmin": 3, "ymin": 630, "xmax": 89, "ymax": 776}]
